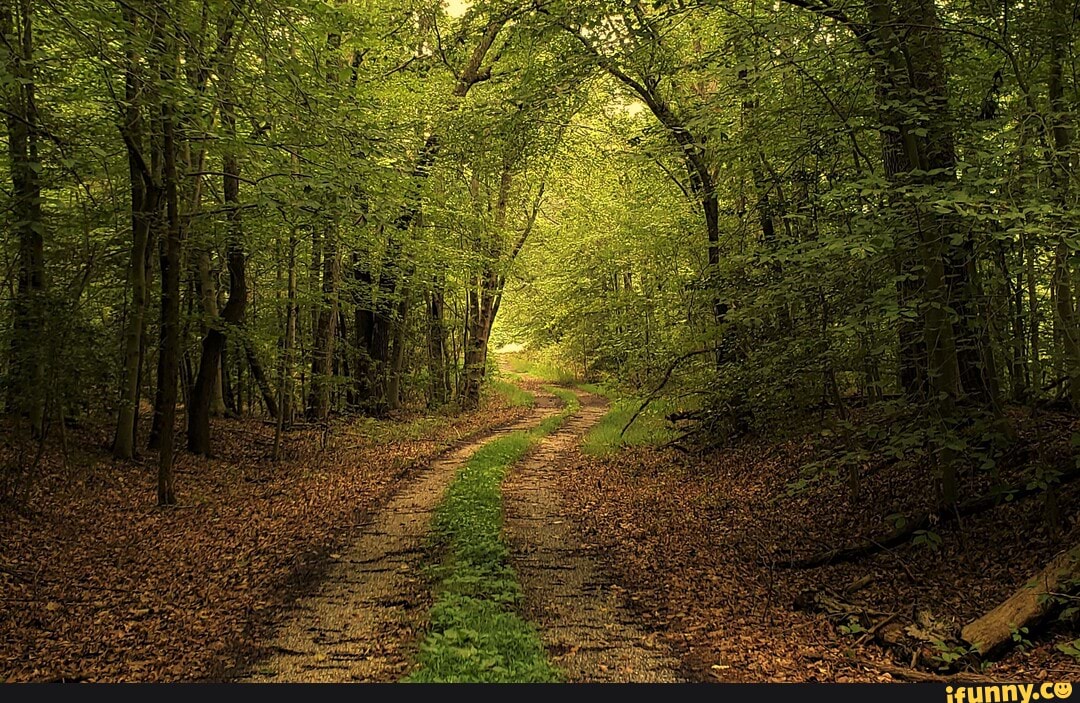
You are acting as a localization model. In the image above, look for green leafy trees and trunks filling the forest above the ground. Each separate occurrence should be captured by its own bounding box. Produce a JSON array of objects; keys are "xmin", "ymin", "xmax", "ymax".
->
[{"xmin": 0, "ymin": 0, "xmax": 1080, "ymax": 516}]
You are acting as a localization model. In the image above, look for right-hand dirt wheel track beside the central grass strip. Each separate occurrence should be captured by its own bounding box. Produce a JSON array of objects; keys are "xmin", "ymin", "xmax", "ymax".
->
[{"xmin": 503, "ymin": 393, "xmax": 679, "ymax": 682}]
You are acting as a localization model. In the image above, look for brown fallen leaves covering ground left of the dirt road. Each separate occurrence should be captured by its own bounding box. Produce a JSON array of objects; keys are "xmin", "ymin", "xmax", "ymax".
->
[{"xmin": 0, "ymin": 403, "xmax": 525, "ymax": 681}]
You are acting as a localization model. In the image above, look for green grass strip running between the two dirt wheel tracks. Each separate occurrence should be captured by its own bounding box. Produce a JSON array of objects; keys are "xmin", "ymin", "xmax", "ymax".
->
[{"xmin": 405, "ymin": 389, "xmax": 579, "ymax": 682}]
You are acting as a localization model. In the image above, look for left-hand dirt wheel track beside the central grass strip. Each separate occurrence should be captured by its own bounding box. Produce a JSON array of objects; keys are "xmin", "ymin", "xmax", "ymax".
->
[{"xmin": 239, "ymin": 393, "xmax": 559, "ymax": 682}]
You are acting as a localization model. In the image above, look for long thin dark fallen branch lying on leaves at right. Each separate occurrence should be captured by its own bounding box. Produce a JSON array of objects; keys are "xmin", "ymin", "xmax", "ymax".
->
[{"xmin": 777, "ymin": 470, "xmax": 1080, "ymax": 569}]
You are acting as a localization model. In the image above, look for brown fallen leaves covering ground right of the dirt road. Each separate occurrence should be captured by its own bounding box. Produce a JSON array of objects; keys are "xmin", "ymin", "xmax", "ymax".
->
[{"xmin": 562, "ymin": 418, "xmax": 1080, "ymax": 681}]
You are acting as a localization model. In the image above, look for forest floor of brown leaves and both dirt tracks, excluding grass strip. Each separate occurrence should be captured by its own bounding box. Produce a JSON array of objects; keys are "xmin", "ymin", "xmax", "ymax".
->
[{"xmin": 0, "ymin": 381, "xmax": 1080, "ymax": 681}]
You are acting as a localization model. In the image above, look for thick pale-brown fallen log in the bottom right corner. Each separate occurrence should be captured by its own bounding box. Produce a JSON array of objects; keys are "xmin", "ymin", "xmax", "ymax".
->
[{"xmin": 960, "ymin": 546, "xmax": 1080, "ymax": 657}]
